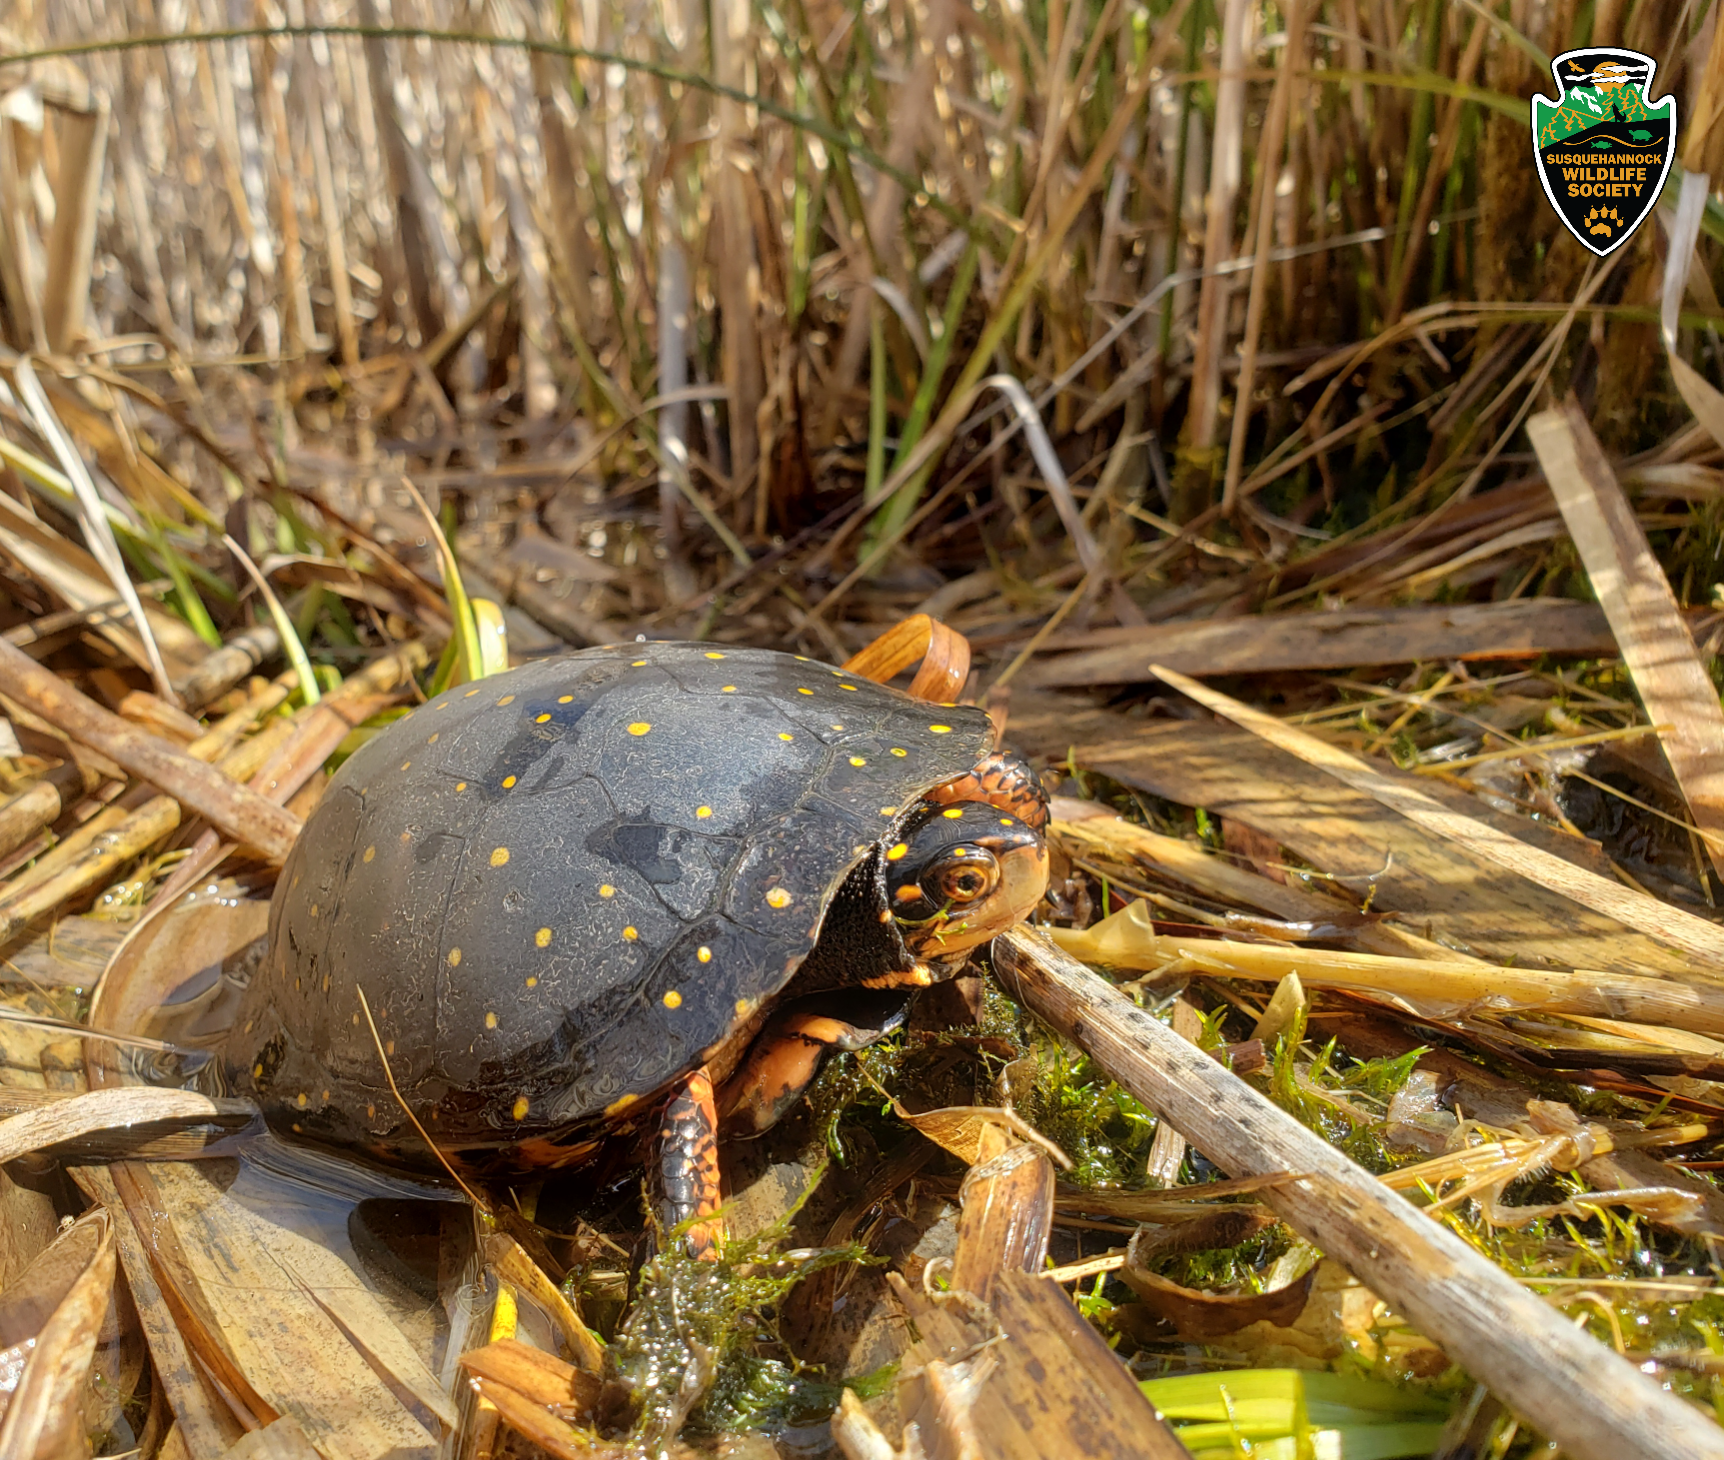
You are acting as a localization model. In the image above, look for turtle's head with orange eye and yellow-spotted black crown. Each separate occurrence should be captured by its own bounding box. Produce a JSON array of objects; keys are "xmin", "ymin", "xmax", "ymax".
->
[{"xmin": 886, "ymin": 802, "xmax": 1048, "ymax": 960}]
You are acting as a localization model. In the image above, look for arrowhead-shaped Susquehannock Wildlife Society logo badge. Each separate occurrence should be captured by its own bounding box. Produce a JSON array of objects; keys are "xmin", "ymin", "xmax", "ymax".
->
[{"xmin": 1533, "ymin": 47, "xmax": 1676, "ymax": 259}]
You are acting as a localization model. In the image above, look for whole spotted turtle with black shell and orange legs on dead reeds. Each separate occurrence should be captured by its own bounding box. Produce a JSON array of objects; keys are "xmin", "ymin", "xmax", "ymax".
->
[{"xmin": 228, "ymin": 643, "xmax": 1046, "ymax": 1220}]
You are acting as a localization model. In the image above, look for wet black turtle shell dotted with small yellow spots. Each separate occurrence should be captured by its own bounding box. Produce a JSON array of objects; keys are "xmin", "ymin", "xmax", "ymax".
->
[{"xmin": 229, "ymin": 643, "xmax": 993, "ymax": 1165}]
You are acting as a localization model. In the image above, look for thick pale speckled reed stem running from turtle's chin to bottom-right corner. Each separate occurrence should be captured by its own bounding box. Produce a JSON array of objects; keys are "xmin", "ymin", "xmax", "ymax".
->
[{"xmin": 993, "ymin": 929, "xmax": 1724, "ymax": 1460}]
